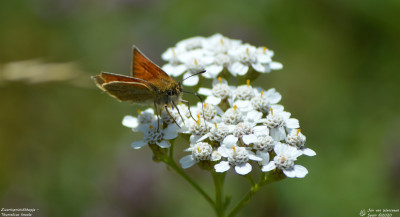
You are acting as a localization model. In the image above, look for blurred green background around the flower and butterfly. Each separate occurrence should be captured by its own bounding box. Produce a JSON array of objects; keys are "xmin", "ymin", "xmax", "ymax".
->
[{"xmin": 0, "ymin": 0, "xmax": 400, "ymax": 217}]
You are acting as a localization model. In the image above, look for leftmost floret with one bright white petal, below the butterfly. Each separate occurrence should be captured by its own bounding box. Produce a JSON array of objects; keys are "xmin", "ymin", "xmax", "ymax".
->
[{"xmin": 122, "ymin": 108, "xmax": 156, "ymax": 132}]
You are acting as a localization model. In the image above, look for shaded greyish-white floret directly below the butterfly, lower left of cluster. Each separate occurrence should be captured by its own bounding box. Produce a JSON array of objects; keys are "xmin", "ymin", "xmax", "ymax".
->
[{"xmin": 131, "ymin": 122, "xmax": 179, "ymax": 149}]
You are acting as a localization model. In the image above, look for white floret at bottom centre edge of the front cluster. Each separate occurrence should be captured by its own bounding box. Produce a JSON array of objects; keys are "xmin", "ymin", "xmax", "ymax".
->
[{"xmin": 214, "ymin": 146, "xmax": 262, "ymax": 175}]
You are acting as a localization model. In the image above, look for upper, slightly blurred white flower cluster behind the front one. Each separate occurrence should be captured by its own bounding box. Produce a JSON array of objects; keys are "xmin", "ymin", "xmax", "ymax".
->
[{"xmin": 162, "ymin": 34, "xmax": 282, "ymax": 86}]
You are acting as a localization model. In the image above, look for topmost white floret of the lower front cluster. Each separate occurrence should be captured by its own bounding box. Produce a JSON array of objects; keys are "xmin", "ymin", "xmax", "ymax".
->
[{"xmin": 199, "ymin": 77, "xmax": 232, "ymax": 105}]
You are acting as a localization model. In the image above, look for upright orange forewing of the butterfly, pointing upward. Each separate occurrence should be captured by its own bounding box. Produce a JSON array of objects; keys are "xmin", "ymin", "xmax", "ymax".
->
[{"xmin": 131, "ymin": 46, "xmax": 176, "ymax": 90}]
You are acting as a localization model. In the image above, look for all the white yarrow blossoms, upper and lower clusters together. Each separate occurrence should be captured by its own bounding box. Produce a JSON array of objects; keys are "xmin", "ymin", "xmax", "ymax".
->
[{"xmin": 122, "ymin": 34, "xmax": 316, "ymax": 178}]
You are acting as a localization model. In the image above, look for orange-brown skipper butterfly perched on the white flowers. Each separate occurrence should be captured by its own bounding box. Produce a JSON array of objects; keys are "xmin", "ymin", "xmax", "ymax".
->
[{"xmin": 92, "ymin": 46, "xmax": 205, "ymax": 126}]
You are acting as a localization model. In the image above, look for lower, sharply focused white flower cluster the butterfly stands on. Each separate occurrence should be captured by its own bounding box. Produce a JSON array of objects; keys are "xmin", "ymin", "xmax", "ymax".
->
[{"xmin": 123, "ymin": 78, "xmax": 315, "ymax": 178}]
